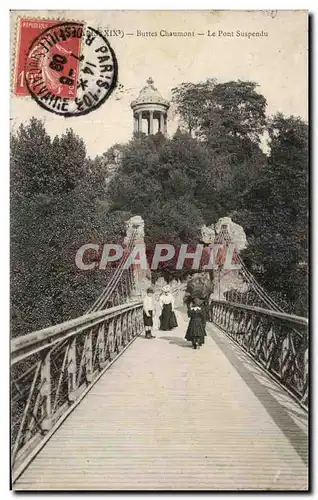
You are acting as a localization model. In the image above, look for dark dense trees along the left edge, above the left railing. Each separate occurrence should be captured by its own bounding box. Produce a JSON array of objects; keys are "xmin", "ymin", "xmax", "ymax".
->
[{"xmin": 11, "ymin": 119, "xmax": 126, "ymax": 336}]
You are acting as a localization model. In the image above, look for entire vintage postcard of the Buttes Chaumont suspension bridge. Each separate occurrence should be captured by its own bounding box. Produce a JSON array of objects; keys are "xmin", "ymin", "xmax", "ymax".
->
[{"xmin": 10, "ymin": 10, "xmax": 310, "ymax": 492}]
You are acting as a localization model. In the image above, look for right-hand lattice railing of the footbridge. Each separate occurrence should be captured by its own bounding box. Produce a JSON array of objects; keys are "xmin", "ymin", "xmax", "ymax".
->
[{"xmin": 210, "ymin": 300, "xmax": 308, "ymax": 410}]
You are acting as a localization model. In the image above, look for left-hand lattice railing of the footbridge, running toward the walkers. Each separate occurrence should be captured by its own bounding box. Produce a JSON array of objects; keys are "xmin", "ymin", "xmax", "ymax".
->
[{"xmin": 11, "ymin": 302, "xmax": 143, "ymax": 480}]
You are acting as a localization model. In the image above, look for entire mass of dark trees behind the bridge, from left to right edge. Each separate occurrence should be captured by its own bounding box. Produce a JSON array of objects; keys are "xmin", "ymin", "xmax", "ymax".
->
[{"xmin": 11, "ymin": 79, "xmax": 308, "ymax": 335}]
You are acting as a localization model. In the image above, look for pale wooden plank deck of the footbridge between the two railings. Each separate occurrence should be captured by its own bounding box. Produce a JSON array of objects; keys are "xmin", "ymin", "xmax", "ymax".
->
[{"xmin": 14, "ymin": 312, "xmax": 307, "ymax": 490}]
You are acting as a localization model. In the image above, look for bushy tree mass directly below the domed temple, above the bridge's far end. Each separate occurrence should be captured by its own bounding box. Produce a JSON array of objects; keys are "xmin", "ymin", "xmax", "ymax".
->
[{"xmin": 108, "ymin": 134, "xmax": 209, "ymax": 278}]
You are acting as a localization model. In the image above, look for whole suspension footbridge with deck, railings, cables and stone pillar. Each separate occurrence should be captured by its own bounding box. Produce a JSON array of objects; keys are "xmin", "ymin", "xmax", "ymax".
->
[{"xmin": 11, "ymin": 218, "xmax": 309, "ymax": 491}]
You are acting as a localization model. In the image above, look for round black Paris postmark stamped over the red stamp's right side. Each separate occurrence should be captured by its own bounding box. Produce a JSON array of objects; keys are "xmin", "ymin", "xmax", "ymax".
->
[{"xmin": 25, "ymin": 22, "xmax": 118, "ymax": 117}]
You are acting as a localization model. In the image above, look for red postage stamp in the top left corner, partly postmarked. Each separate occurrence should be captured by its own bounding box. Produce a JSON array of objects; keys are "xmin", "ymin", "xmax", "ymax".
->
[{"xmin": 14, "ymin": 19, "xmax": 82, "ymax": 99}]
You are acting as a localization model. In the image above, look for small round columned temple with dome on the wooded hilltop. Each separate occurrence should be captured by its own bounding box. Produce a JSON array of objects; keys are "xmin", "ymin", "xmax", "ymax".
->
[{"xmin": 131, "ymin": 78, "xmax": 170, "ymax": 135}]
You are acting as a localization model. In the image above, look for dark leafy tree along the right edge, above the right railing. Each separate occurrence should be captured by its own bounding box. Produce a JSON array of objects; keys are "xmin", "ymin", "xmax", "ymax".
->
[{"xmin": 236, "ymin": 114, "xmax": 308, "ymax": 315}]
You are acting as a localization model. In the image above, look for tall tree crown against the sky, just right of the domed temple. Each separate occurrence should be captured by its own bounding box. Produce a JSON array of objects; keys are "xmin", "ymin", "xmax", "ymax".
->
[{"xmin": 172, "ymin": 79, "xmax": 266, "ymax": 143}]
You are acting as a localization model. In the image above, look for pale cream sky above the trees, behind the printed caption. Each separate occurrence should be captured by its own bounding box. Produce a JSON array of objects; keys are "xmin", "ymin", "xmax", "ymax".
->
[{"xmin": 10, "ymin": 11, "xmax": 308, "ymax": 157}]
